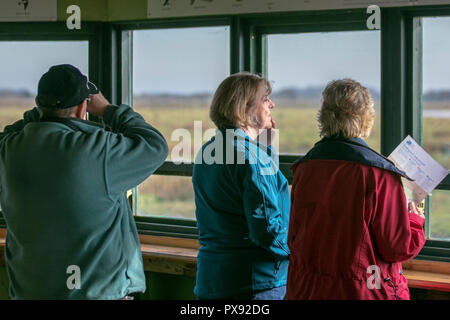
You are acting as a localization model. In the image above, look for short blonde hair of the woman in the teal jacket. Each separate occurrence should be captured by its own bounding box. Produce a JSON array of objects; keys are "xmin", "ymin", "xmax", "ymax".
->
[{"xmin": 209, "ymin": 71, "xmax": 272, "ymax": 129}]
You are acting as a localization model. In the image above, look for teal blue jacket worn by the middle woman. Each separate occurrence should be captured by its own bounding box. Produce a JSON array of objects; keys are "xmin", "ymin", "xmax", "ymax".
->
[{"xmin": 192, "ymin": 129, "xmax": 290, "ymax": 299}]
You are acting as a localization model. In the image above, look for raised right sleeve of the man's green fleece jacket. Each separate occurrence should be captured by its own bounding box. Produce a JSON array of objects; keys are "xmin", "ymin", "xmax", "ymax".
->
[{"xmin": 103, "ymin": 105, "xmax": 168, "ymax": 196}]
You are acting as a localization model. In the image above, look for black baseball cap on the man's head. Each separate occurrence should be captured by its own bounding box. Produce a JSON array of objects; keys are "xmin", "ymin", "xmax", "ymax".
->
[{"xmin": 36, "ymin": 64, "xmax": 99, "ymax": 109}]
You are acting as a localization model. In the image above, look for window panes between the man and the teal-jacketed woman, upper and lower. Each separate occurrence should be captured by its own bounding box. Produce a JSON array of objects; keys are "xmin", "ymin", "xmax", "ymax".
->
[{"xmin": 133, "ymin": 26, "xmax": 230, "ymax": 219}]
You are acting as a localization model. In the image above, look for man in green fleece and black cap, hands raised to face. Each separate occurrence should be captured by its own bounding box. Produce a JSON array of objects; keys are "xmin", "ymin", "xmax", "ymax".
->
[{"xmin": 0, "ymin": 65, "xmax": 168, "ymax": 299}]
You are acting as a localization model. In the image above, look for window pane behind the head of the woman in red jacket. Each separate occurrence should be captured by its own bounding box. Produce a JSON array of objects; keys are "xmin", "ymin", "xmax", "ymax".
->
[{"xmin": 267, "ymin": 31, "xmax": 380, "ymax": 154}]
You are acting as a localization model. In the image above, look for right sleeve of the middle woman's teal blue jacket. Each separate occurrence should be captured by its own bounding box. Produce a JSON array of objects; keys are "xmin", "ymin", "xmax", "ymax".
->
[{"xmin": 243, "ymin": 164, "xmax": 289, "ymax": 260}]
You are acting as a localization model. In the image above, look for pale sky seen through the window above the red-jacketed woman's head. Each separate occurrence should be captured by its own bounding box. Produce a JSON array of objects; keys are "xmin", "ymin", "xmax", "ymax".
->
[{"xmin": 268, "ymin": 31, "xmax": 380, "ymax": 94}]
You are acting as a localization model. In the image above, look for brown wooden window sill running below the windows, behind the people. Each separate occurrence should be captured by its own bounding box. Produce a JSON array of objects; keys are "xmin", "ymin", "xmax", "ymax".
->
[{"xmin": 0, "ymin": 229, "xmax": 450, "ymax": 292}]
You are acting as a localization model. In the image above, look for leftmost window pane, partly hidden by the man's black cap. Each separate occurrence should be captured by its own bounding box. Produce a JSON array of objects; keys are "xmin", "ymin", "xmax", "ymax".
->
[{"xmin": 0, "ymin": 41, "xmax": 89, "ymax": 131}]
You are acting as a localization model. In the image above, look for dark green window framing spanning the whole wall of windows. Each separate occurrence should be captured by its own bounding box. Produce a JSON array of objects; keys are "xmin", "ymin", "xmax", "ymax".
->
[{"xmin": 0, "ymin": 5, "xmax": 450, "ymax": 261}]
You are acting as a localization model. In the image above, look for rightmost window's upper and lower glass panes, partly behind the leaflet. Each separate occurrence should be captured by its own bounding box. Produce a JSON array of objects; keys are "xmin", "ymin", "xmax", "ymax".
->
[{"xmin": 422, "ymin": 17, "xmax": 450, "ymax": 240}]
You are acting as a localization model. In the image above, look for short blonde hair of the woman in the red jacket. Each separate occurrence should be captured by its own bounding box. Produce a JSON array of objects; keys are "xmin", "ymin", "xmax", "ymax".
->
[{"xmin": 318, "ymin": 79, "xmax": 375, "ymax": 139}]
